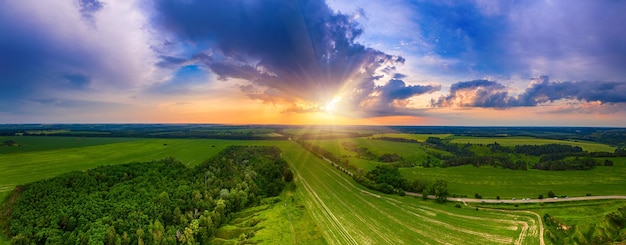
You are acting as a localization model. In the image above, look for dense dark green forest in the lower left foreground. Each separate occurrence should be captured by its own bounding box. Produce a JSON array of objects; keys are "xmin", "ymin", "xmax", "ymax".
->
[{"xmin": 0, "ymin": 146, "xmax": 293, "ymax": 244}]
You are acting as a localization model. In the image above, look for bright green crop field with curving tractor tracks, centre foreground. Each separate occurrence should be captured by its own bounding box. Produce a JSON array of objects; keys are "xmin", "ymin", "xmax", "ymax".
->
[{"xmin": 284, "ymin": 141, "xmax": 539, "ymax": 244}]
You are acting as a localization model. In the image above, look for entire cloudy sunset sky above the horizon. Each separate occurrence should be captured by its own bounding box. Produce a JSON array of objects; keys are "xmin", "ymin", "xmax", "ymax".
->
[{"xmin": 0, "ymin": 0, "xmax": 626, "ymax": 127}]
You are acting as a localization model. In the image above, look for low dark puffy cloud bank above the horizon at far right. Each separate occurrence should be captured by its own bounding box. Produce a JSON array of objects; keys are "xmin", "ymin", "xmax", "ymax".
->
[{"xmin": 431, "ymin": 76, "xmax": 626, "ymax": 112}]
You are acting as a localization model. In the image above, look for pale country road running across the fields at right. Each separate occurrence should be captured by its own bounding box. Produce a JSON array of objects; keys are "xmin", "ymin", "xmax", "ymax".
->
[{"xmin": 405, "ymin": 192, "xmax": 626, "ymax": 203}]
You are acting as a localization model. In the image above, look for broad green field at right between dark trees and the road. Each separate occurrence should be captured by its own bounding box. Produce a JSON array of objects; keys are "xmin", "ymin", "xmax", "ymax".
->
[{"xmin": 400, "ymin": 157, "xmax": 626, "ymax": 199}]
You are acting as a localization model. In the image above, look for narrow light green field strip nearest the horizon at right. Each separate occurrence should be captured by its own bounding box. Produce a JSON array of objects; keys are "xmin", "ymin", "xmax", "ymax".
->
[{"xmin": 451, "ymin": 136, "xmax": 615, "ymax": 152}]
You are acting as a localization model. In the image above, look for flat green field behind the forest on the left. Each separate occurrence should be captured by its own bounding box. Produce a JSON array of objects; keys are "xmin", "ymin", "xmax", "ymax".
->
[{"xmin": 0, "ymin": 136, "xmax": 286, "ymax": 197}]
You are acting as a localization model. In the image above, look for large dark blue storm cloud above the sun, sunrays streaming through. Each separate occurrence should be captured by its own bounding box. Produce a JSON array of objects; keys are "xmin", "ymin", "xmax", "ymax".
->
[{"xmin": 153, "ymin": 0, "xmax": 424, "ymax": 115}]
